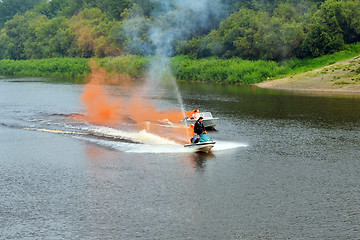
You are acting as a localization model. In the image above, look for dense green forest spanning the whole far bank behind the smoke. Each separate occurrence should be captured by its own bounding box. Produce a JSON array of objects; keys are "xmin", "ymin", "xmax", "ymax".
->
[{"xmin": 0, "ymin": 0, "xmax": 360, "ymax": 61}]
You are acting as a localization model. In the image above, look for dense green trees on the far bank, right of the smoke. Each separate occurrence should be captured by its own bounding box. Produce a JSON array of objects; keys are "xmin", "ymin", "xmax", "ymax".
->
[{"xmin": 178, "ymin": 0, "xmax": 360, "ymax": 61}]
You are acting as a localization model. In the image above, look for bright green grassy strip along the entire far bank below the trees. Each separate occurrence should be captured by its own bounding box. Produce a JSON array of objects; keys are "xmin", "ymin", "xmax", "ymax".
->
[{"xmin": 0, "ymin": 43, "xmax": 360, "ymax": 84}]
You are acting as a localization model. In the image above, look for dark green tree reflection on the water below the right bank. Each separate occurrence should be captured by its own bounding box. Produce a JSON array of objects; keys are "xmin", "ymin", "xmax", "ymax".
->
[{"xmin": 180, "ymin": 81, "xmax": 360, "ymax": 126}]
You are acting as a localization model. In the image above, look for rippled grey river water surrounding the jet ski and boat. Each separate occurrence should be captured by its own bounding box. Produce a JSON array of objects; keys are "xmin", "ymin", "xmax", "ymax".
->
[{"xmin": 0, "ymin": 77, "xmax": 360, "ymax": 239}]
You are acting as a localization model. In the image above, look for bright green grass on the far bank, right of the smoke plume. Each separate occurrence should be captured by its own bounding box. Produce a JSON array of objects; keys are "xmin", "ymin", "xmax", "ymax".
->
[{"xmin": 172, "ymin": 43, "xmax": 360, "ymax": 84}]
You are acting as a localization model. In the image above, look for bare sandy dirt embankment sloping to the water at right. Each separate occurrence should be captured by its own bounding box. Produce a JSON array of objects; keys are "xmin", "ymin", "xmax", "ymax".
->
[{"xmin": 256, "ymin": 56, "xmax": 360, "ymax": 94}]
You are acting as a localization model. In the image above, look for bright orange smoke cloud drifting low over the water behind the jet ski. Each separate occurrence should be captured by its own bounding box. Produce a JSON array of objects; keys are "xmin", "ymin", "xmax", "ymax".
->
[{"xmin": 81, "ymin": 61, "xmax": 188, "ymax": 143}]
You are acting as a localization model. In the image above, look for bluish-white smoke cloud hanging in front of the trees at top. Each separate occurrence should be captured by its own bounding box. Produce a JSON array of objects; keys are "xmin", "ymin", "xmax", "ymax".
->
[{"xmin": 123, "ymin": 0, "xmax": 228, "ymax": 57}]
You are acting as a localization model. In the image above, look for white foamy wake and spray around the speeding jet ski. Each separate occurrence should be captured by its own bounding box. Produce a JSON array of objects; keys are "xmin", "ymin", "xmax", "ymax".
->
[{"xmin": 2, "ymin": 111, "xmax": 248, "ymax": 153}]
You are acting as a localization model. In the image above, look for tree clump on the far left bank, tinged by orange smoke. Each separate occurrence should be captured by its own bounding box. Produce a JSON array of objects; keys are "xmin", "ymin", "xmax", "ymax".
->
[{"xmin": 0, "ymin": 8, "xmax": 121, "ymax": 60}]
